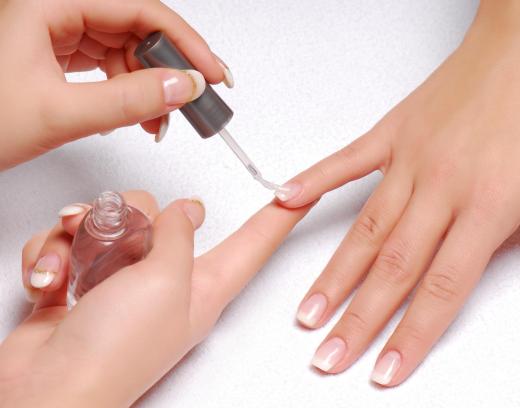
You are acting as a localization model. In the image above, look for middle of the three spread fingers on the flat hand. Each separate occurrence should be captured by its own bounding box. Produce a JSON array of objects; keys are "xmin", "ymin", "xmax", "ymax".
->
[{"xmin": 313, "ymin": 193, "xmax": 451, "ymax": 373}]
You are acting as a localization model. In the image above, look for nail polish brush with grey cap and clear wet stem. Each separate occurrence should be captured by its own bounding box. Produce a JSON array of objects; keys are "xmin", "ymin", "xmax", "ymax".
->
[{"xmin": 135, "ymin": 32, "xmax": 284, "ymax": 191}]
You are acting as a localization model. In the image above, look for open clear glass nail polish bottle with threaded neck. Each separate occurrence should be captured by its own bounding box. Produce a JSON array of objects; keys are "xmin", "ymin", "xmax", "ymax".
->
[{"xmin": 67, "ymin": 192, "xmax": 152, "ymax": 308}]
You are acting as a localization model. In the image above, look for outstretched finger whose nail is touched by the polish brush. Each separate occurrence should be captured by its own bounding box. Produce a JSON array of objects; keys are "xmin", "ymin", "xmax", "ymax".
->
[{"xmin": 276, "ymin": 126, "xmax": 390, "ymax": 208}]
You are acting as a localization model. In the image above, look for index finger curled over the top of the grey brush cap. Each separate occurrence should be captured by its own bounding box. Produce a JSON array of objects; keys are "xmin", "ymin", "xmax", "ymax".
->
[{"xmin": 48, "ymin": 0, "xmax": 224, "ymax": 82}]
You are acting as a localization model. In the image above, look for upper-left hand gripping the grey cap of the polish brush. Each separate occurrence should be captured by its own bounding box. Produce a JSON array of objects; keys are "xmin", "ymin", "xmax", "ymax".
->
[{"xmin": 0, "ymin": 0, "xmax": 232, "ymax": 170}]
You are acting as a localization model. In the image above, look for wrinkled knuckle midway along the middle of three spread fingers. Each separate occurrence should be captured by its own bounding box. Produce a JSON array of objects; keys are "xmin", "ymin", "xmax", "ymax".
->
[{"xmin": 374, "ymin": 243, "xmax": 411, "ymax": 285}]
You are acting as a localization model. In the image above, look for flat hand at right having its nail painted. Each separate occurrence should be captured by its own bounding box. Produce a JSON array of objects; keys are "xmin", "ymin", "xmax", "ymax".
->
[{"xmin": 280, "ymin": 0, "xmax": 520, "ymax": 386}]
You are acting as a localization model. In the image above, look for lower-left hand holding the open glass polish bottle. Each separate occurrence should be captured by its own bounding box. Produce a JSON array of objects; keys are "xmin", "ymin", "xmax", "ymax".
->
[{"xmin": 0, "ymin": 192, "xmax": 309, "ymax": 407}]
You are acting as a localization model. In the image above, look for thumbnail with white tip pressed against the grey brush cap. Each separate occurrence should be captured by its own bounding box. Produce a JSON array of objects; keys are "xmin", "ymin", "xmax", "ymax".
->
[{"xmin": 163, "ymin": 69, "xmax": 206, "ymax": 105}]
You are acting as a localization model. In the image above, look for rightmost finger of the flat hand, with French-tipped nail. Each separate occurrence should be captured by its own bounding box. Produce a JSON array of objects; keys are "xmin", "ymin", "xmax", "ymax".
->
[{"xmin": 372, "ymin": 214, "xmax": 504, "ymax": 386}]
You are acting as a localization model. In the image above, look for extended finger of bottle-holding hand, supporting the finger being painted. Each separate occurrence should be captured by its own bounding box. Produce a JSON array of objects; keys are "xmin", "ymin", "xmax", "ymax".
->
[{"xmin": 192, "ymin": 202, "xmax": 312, "ymax": 323}]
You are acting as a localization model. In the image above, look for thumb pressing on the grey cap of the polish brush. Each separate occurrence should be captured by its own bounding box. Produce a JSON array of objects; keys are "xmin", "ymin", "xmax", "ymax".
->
[{"xmin": 51, "ymin": 68, "xmax": 206, "ymax": 140}]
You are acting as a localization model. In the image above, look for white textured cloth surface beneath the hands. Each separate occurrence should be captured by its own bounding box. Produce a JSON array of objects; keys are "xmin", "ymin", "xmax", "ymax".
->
[{"xmin": 0, "ymin": 0, "xmax": 520, "ymax": 408}]
